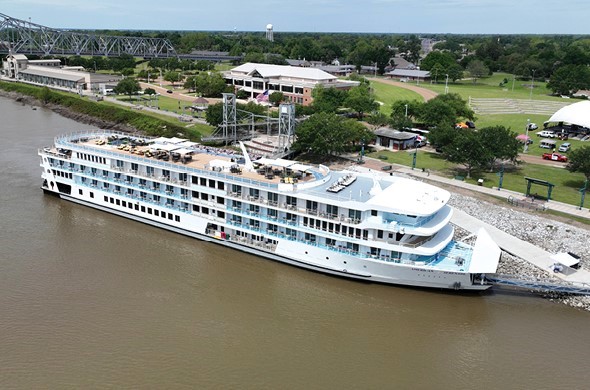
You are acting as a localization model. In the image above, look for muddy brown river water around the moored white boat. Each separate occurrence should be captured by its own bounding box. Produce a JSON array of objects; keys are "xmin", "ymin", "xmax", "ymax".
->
[{"xmin": 0, "ymin": 98, "xmax": 590, "ymax": 389}]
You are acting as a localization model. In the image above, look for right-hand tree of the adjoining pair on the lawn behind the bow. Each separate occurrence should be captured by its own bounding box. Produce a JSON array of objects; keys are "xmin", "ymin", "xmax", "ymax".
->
[{"xmin": 477, "ymin": 126, "xmax": 520, "ymax": 172}]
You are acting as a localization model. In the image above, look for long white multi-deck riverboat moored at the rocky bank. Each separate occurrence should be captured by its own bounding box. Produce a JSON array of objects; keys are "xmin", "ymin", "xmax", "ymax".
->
[{"xmin": 38, "ymin": 130, "xmax": 501, "ymax": 290}]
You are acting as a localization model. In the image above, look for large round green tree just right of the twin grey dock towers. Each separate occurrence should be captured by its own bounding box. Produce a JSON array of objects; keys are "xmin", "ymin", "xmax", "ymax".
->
[{"xmin": 293, "ymin": 112, "xmax": 374, "ymax": 156}]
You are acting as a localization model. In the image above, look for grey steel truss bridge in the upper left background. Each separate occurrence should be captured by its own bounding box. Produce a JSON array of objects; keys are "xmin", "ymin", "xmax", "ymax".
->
[{"xmin": 0, "ymin": 13, "xmax": 178, "ymax": 58}]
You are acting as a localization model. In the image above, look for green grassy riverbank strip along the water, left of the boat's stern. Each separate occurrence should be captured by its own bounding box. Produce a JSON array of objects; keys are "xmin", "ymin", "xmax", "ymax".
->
[{"xmin": 0, "ymin": 81, "xmax": 212, "ymax": 140}]
